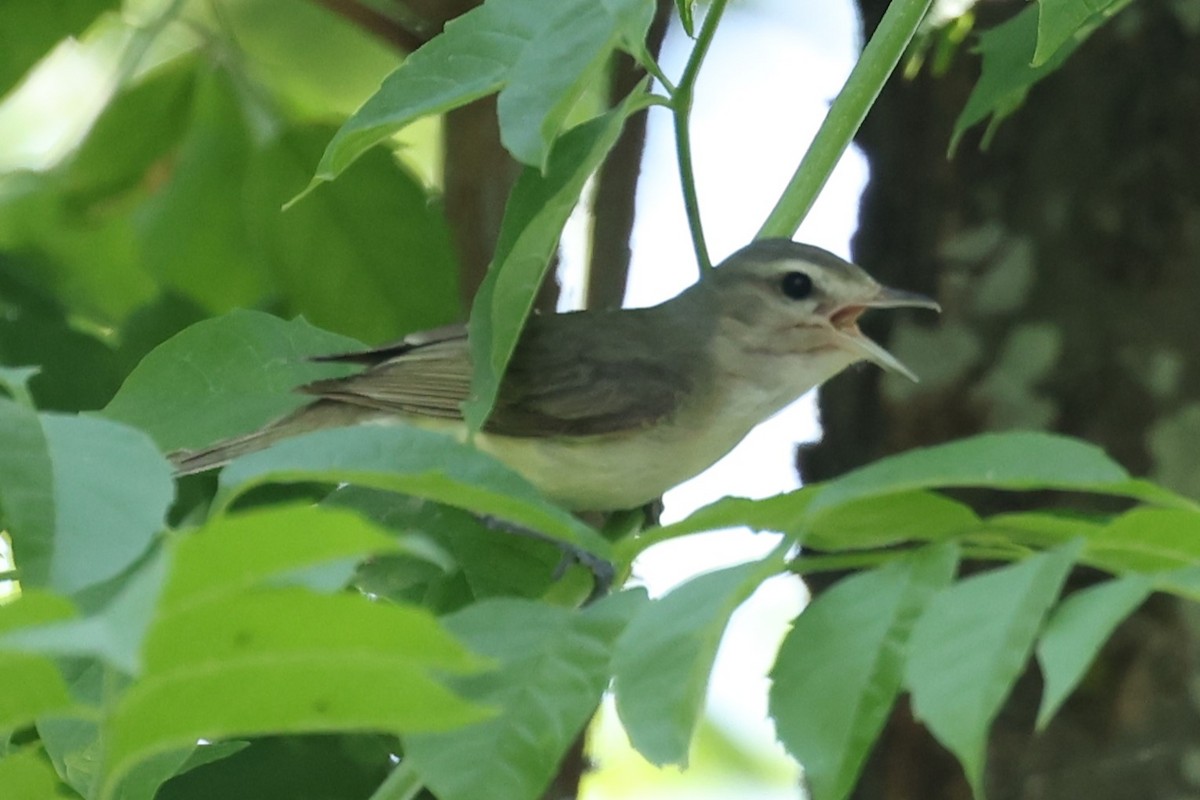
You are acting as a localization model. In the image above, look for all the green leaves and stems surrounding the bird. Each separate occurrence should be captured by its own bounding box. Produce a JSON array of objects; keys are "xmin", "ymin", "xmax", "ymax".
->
[{"xmin": 0, "ymin": 0, "xmax": 1180, "ymax": 800}]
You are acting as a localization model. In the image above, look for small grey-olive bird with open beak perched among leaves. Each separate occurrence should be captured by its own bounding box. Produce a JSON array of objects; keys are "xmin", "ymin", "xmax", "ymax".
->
[{"xmin": 172, "ymin": 239, "xmax": 938, "ymax": 511}]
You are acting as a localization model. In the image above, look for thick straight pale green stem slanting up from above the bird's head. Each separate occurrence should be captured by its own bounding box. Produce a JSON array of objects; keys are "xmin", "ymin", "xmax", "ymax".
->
[{"xmin": 758, "ymin": 0, "xmax": 930, "ymax": 239}]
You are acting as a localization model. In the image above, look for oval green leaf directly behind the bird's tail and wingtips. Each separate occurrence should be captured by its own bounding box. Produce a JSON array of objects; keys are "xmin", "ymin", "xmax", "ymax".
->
[{"xmin": 103, "ymin": 311, "xmax": 361, "ymax": 450}]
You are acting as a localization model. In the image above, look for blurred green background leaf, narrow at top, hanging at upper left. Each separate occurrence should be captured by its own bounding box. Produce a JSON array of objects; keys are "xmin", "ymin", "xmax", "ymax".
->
[{"xmin": 137, "ymin": 70, "xmax": 270, "ymax": 313}]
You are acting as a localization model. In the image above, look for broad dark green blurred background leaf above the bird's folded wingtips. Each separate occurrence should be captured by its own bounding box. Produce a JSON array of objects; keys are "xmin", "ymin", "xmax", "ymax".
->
[{"xmin": 245, "ymin": 126, "xmax": 463, "ymax": 342}]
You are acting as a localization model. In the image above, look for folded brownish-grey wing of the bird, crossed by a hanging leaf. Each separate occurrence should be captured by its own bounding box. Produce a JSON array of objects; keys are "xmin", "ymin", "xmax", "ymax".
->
[{"xmin": 302, "ymin": 311, "xmax": 690, "ymax": 437}]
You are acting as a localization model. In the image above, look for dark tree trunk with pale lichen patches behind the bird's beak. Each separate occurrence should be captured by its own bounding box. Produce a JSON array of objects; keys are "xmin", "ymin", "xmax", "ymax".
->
[{"xmin": 800, "ymin": 0, "xmax": 1200, "ymax": 800}]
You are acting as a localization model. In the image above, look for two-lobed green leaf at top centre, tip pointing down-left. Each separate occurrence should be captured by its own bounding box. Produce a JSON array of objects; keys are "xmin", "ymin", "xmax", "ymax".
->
[{"xmin": 306, "ymin": 0, "xmax": 653, "ymax": 192}]
